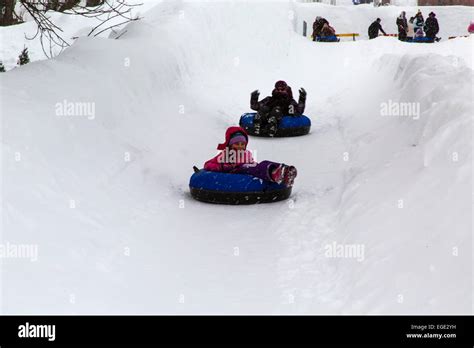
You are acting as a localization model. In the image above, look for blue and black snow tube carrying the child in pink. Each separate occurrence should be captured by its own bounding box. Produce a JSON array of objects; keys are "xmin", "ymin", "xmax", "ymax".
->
[{"xmin": 189, "ymin": 168, "xmax": 291, "ymax": 205}]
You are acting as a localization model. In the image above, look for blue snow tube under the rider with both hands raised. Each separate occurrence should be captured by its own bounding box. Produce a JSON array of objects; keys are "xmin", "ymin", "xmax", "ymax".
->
[{"xmin": 239, "ymin": 112, "xmax": 311, "ymax": 137}]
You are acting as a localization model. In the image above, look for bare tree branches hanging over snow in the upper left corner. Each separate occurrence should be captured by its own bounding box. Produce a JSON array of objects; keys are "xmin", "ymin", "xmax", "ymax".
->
[{"xmin": 0, "ymin": 0, "xmax": 142, "ymax": 57}]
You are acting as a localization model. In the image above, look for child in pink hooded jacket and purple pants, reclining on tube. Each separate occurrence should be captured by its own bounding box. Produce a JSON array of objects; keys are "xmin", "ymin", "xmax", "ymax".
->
[{"xmin": 204, "ymin": 127, "xmax": 297, "ymax": 187}]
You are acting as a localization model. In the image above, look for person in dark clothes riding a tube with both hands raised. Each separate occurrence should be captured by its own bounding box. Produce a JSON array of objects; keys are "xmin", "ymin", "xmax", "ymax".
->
[{"xmin": 250, "ymin": 80, "xmax": 306, "ymax": 136}]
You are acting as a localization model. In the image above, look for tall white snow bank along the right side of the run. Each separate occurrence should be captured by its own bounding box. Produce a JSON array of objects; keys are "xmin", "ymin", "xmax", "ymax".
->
[{"xmin": 312, "ymin": 55, "xmax": 473, "ymax": 314}]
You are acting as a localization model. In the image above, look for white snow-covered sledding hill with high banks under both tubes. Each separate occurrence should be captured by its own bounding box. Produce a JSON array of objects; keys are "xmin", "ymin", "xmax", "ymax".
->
[{"xmin": 0, "ymin": 1, "xmax": 473, "ymax": 313}]
